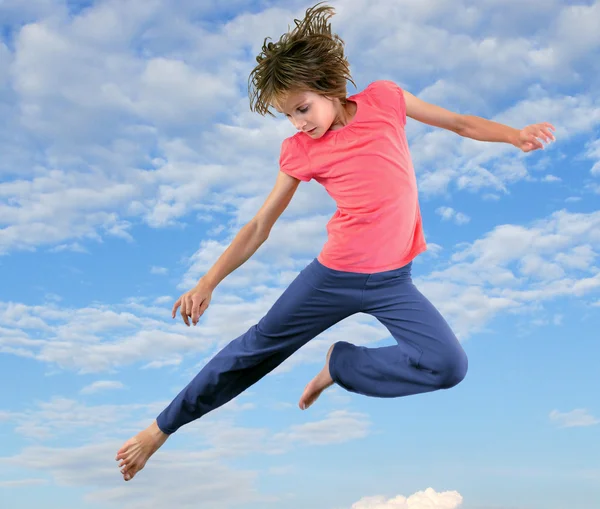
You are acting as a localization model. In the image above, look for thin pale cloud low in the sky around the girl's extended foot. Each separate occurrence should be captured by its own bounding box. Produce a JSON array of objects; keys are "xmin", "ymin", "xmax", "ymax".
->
[{"xmin": 0, "ymin": 397, "xmax": 369, "ymax": 509}]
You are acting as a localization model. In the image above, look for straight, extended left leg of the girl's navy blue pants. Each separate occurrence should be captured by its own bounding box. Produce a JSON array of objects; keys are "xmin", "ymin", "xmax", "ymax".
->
[{"xmin": 157, "ymin": 260, "xmax": 364, "ymax": 434}]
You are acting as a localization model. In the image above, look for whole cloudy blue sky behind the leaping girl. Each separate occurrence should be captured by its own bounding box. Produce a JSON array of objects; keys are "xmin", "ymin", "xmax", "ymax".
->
[{"xmin": 0, "ymin": 0, "xmax": 600, "ymax": 509}]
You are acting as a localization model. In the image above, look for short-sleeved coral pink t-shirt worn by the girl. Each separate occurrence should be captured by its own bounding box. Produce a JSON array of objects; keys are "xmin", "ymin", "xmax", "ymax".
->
[{"xmin": 280, "ymin": 80, "xmax": 426, "ymax": 273}]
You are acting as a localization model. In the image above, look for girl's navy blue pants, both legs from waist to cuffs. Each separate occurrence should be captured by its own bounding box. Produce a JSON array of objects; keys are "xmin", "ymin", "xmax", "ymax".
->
[{"xmin": 157, "ymin": 259, "xmax": 467, "ymax": 434}]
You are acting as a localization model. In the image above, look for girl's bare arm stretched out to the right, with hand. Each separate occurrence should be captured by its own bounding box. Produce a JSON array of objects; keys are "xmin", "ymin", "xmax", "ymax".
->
[{"xmin": 403, "ymin": 90, "xmax": 555, "ymax": 152}]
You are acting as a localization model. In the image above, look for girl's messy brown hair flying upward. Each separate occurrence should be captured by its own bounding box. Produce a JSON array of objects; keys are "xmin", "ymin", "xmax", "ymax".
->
[{"xmin": 248, "ymin": 2, "xmax": 356, "ymax": 116}]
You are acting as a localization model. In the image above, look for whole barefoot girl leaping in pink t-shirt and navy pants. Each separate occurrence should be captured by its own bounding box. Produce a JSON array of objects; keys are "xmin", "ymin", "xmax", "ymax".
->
[{"xmin": 116, "ymin": 3, "xmax": 554, "ymax": 481}]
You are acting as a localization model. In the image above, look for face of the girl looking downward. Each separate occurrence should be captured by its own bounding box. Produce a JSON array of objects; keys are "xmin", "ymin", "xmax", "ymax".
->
[{"xmin": 276, "ymin": 92, "xmax": 339, "ymax": 139}]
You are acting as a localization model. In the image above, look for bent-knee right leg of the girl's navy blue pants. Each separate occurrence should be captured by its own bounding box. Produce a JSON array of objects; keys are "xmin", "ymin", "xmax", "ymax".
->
[{"xmin": 329, "ymin": 264, "xmax": 468, "ymax": 398}]
